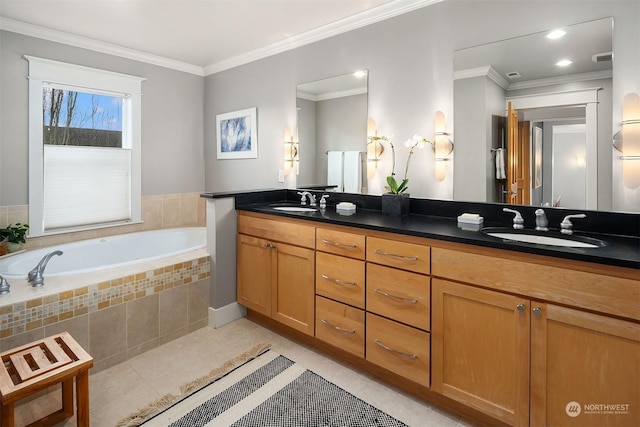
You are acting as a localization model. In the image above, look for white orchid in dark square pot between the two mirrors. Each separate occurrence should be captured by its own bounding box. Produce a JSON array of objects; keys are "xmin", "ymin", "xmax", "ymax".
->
[{"xmin": 382, "ymin": 135, "xmax": 431, "ymax": 215}]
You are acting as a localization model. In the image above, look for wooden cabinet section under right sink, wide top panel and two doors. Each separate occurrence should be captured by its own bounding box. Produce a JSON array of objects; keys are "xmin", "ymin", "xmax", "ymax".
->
[{"xmin": 431, "ymin": 248, "xmax": 640, "ymax": 426}]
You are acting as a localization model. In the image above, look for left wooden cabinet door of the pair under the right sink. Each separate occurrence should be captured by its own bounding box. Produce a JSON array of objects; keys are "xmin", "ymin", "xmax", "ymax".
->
[{"xmin": 431, "ymin": 279, "xmax": 530, "ymax": 426}]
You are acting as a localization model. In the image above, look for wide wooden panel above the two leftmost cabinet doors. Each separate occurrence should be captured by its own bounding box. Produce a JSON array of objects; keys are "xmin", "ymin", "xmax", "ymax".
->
[{"xmin": 238, "ymin": 214, "xmax": 316, "ymax": 249}]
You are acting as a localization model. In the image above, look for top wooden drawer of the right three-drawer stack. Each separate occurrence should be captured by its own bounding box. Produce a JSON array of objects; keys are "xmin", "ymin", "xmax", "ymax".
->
[{"xmin": 367, "ymin": 237, "xmax": 431, "ymax": 274}]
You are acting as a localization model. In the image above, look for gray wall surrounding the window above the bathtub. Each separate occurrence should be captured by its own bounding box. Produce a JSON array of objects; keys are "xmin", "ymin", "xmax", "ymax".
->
[{"xmin": 0, "ymin": 31, "xmax": 204, "ymax": 206}]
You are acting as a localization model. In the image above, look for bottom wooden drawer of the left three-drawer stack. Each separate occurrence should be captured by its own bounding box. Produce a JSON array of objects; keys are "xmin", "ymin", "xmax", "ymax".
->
[{"xmin": 316, "ymin": 296, "xmax": 364, "ymax": 358}]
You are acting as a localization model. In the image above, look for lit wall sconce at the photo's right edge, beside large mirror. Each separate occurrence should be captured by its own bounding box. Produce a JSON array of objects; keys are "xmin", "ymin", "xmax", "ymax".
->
[{"xmin": 613, "ymin": 93, "xmax": 640, "ymax": 189}]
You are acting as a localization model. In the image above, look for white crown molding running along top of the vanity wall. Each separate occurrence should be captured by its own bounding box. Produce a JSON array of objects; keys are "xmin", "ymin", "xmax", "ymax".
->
[{"xmin": 204, "ymin": 0, "xmax": 445, "ymax": 76}]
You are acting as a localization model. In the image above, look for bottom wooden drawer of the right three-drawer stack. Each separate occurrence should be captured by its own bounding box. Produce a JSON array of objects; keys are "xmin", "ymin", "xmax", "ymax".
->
[{"xmin": 366, "ymin": 313, "xmax": 431, "ymax": 387}]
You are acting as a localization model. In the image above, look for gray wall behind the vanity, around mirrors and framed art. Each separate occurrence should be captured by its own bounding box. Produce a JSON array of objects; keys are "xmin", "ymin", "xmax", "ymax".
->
[{"xmin": 204, "ymin": 0, "xmax": 640, "ymax": 208}]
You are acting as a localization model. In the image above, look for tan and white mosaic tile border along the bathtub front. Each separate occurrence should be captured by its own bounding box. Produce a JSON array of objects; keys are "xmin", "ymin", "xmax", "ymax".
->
[{"xmin": 0, "ymin": 256, "xmax": 211, "ymax": 338}]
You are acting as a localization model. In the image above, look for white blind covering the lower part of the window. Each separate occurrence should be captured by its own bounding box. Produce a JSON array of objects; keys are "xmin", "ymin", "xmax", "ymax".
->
[{"xmin": 43, "ymin": 145, "xmax": 131, "ymax": 232}]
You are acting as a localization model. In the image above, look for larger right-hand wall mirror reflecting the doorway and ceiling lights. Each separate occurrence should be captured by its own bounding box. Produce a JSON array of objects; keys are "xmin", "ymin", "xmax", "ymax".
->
[{"xmin": 454, "ymin": 18, "xmax": 624, "ymax": 210}]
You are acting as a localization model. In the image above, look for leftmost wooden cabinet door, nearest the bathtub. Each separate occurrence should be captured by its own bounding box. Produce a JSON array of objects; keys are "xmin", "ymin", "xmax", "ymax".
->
[{"xmin": 237, "ymin": 234, "xmax": 274, "ymax": 316}]
